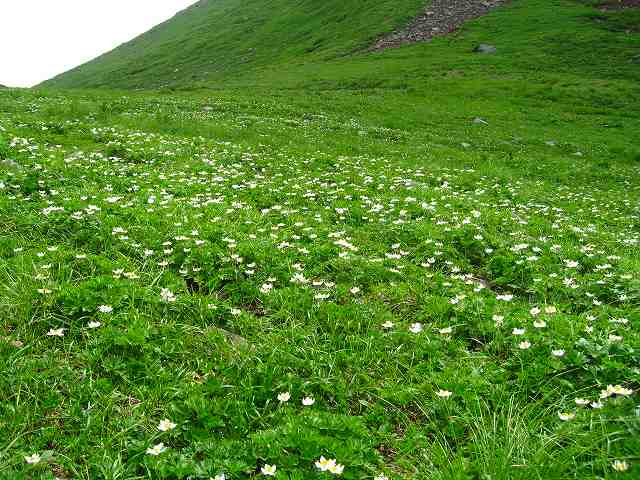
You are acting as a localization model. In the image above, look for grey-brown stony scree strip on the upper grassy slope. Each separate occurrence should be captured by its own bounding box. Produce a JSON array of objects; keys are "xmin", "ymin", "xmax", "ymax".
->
[{"xmin": 370, "ymin": 0, "xmax": 510, "ymax": 51}]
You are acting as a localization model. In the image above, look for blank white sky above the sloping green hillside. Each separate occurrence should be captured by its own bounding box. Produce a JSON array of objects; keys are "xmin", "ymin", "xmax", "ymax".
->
[{"xmin": 0, "ymin": 0, "xmax": 196, "ymax": 87}]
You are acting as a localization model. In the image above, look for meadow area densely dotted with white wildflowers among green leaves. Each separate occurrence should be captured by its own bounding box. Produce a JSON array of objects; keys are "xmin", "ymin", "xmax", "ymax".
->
[{"xmin": 0, "ymin": 89, "xmax": 640, "ymax": 479}]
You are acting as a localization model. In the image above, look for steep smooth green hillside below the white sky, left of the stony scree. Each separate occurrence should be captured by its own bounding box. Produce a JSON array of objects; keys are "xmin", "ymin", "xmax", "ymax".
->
[{"xmin": 46, "ymin": 0, "xmax": 424, "ymax": 88}]
